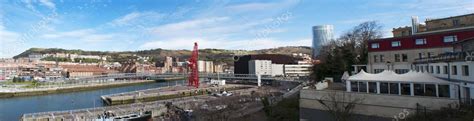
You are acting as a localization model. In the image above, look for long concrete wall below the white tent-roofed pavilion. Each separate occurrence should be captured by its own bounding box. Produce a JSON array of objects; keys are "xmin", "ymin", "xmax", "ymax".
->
[{"xmin": 300, "ymin": 90, "xmax": 458, "ymax": 118}]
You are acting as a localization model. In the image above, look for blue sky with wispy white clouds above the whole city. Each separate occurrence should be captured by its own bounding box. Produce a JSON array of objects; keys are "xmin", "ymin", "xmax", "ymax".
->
[{"xmin": 0, "ymin": 0, "xmax": 474, "ymax": 58}]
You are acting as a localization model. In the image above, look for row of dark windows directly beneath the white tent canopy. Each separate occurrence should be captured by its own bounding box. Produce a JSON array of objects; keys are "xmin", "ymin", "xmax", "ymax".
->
[{"xmin": 351, "ymin": 81, "xmax": 450, "ymax": 97}]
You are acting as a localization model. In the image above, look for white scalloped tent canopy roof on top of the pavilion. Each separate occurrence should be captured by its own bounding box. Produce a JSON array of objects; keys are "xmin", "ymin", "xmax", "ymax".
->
[{"xmin": 347, "ymin": 70, "xmax": 451, "ymax": 84}]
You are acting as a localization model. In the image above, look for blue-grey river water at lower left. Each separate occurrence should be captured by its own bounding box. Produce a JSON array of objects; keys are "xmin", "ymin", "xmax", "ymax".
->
[{"xmin": 0, "ymin": 81, "xmax": 184, "ymax": 121}]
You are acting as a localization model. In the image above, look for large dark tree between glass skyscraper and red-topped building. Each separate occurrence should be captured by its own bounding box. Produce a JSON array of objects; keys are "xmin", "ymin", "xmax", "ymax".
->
[{"xmin": 312, "ymin": 21, "xmax": 382, "ymax": 81}]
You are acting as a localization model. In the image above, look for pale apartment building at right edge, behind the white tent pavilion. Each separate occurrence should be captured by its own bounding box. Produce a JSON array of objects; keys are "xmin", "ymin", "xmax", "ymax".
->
[{"xmin": 414, "ymin": 38, "xmax": 474, "ymax": 104}]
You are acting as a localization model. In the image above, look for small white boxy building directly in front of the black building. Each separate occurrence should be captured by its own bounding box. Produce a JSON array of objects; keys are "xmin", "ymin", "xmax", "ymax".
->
[{"xmin": 249, "ymin": 60, "xmax": 272, "ymax": 75}]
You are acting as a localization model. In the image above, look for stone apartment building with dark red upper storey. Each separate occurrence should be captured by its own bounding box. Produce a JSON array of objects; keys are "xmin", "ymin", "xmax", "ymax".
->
[{"xmin": 367, "ymin": 14, "xmax": 474, "ymax": 74}]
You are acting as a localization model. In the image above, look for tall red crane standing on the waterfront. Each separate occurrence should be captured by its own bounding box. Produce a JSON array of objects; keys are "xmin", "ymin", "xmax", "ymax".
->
[{"xmin": 188, "ymin": 42, "xmax": 199, "ymax": 88}]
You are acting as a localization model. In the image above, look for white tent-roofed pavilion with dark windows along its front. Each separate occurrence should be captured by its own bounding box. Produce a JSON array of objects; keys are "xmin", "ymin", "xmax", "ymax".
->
[{"xmin": 346, "ymin": 70, "xmax": 458, "ymax": 99}]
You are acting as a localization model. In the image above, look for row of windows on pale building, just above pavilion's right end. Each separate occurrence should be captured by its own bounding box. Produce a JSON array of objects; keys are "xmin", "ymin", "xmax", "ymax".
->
[{"xmin": 415, "ymin": 65, "xmax": 469, "ymax": 76}]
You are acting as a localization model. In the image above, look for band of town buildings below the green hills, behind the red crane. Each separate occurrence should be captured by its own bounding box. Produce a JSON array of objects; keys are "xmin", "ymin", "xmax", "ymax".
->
[{"xmin": 0, "ymin": 53, "xmax": 311, "ymax": 81}]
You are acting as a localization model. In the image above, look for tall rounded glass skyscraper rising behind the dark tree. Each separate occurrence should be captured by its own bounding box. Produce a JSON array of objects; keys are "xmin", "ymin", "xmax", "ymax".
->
[{"xmin": 312, "ymin": 25, "xmax": 334, "ymax": 58}]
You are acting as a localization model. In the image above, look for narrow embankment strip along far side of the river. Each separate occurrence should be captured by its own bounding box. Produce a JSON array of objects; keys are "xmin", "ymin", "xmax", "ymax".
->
[{"xmin": 0, "ymin": 80, "xmax": 160, "ymax": 98}]
